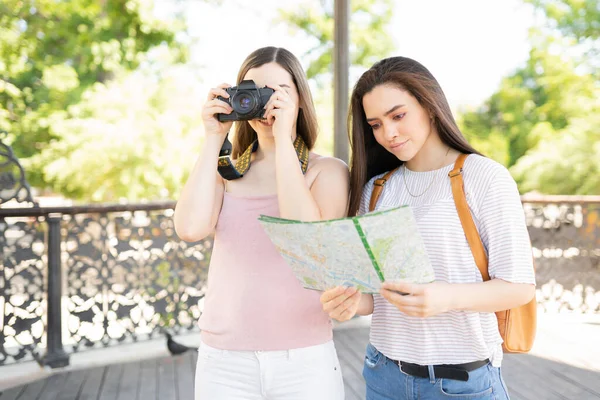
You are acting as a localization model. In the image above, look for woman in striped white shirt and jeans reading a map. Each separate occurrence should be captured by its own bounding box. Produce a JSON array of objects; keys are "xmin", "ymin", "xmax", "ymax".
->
[{"xmin": 321, "ymin": 57, "xmax": 535, "ymax": 400}]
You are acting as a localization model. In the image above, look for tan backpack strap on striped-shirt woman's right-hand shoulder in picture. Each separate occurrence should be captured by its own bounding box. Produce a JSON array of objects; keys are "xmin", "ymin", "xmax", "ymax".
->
[{"xmin": 448, "ymin": 154, "xmax": 490, "ymax": 281}]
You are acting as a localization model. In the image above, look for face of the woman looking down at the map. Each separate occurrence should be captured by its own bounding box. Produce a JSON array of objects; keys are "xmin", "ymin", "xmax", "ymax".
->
[{"xmin": 362, "ymin": 84, "xmax": 433, "ymax": 162}]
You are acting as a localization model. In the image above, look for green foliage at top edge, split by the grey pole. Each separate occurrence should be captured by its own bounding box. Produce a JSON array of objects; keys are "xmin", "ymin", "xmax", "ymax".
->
[{"xmin": 279, "ymin": 0, "xmax": 394, "ymax": 78}]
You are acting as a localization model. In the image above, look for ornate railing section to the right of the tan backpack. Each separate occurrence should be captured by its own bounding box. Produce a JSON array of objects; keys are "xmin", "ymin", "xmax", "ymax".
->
[{"xmin": 524, "ymin": 203, "xmax": 600, "ymax": 313}]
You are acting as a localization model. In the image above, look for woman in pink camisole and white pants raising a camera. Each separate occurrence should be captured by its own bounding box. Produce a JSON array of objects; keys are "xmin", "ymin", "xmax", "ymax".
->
[{"xmin": 175, "ymin": 47, "xmax": 349, "ymax": 400}]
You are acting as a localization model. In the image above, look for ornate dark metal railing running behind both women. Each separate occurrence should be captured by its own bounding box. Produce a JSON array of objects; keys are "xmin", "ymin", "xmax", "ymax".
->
[{"xmin": 0, "ymin": 134, "xmax": 600, "ymax": 367}]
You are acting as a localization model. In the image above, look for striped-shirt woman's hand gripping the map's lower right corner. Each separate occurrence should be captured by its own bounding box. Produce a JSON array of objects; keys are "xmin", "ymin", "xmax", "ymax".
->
[{"xmin": 379, "ymin": 282, "xmax": 454, "ymax": 318}]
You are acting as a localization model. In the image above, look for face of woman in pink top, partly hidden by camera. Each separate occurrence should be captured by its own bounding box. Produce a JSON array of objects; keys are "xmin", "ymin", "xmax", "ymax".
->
[{"xmin": 244, "ymin": 62, "xmax": 300, "ymax": 137}]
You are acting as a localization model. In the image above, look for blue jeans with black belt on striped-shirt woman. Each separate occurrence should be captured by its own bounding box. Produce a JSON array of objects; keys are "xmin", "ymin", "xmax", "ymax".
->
[{"xmin": 363, "ymin": 343, "xmax": 509, "ymax": 400}]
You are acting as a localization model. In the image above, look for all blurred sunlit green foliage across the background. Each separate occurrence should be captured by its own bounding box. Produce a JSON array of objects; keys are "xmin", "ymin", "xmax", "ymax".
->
[{"xmin": 0, "ymin": 0, "xmax": 600, "ymax": 202}]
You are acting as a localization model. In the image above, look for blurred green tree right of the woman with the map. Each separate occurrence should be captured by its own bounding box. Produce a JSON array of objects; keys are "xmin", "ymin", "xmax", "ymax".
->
[{"xmin": 459, "ymin": 0, "xmax": 600, "ymax": 194}]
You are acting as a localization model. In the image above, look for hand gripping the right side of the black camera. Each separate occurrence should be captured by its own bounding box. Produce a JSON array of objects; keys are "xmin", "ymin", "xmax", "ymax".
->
[{"xmin": 264, "ymin": 85, "xmax": 297, "ymax": 139}]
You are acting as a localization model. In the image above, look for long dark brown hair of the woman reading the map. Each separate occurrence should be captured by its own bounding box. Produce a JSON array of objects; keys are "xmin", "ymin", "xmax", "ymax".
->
[{"xmin": 348, "ymin": 57, "xmax": 479, "ymax": 216}]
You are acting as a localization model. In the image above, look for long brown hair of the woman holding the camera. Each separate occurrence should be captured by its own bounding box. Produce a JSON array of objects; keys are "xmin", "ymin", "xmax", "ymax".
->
[{"xmin": 232, "ymin": 47, "xmax": 319, "ymax": 158}]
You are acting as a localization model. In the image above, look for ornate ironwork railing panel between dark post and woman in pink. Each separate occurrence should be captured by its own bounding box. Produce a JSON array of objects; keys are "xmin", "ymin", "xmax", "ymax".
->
[{"xmin": 63, "ymin": 210, "xmax": 211, "ymax": 351}]
